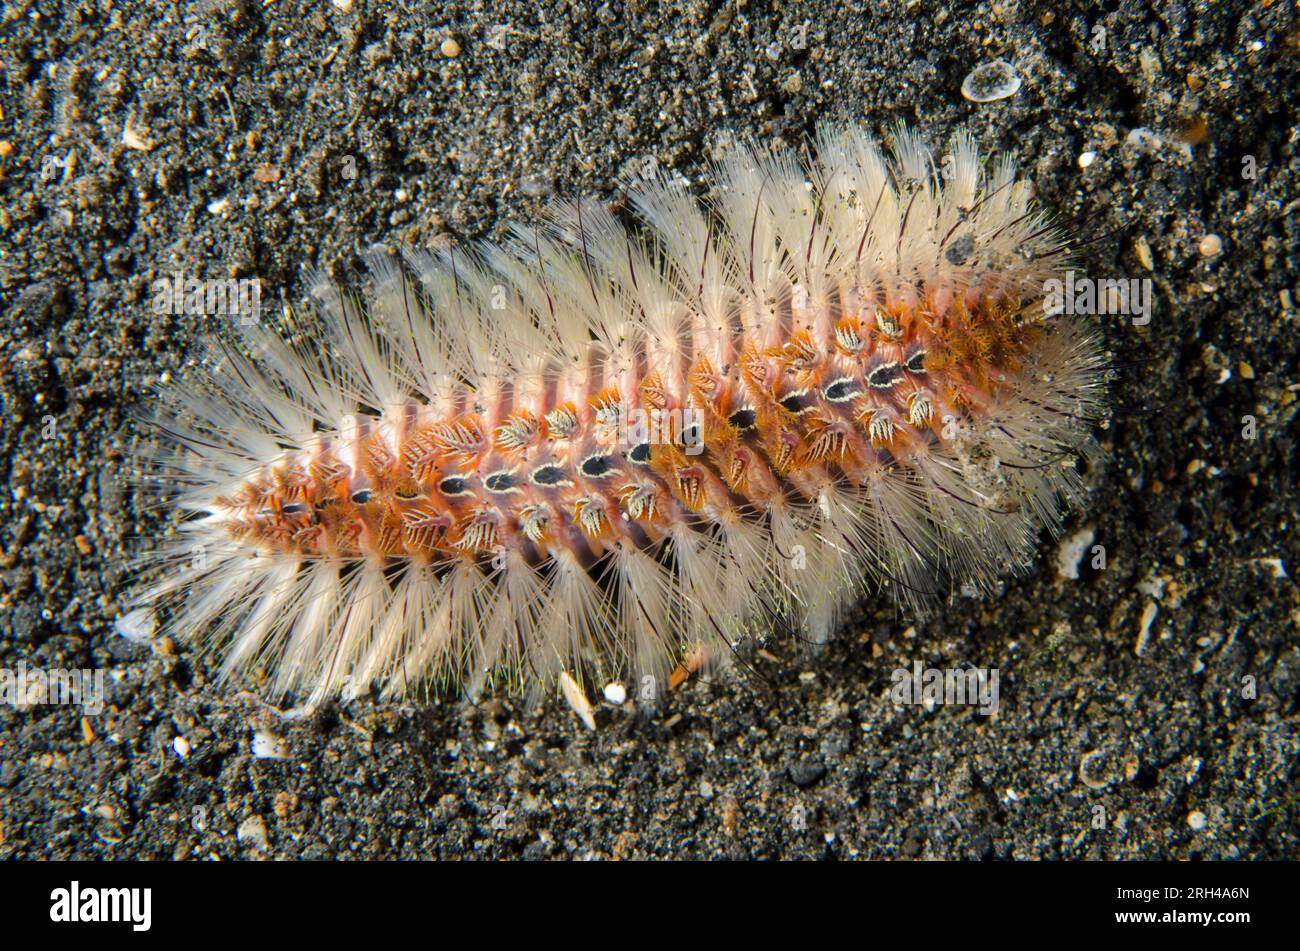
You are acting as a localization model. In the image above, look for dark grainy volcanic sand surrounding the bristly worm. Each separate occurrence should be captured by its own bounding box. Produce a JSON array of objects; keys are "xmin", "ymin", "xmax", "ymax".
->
[{"xmin": 0, "ymin": 0, "xmax": 1300, "ymax": 859}]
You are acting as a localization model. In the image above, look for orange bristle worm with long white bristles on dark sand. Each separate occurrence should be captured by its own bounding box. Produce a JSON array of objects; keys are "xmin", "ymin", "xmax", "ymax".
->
[{"xmin": 146, "ymin": 127, "xmax": 1105, "ymax": 703}]
